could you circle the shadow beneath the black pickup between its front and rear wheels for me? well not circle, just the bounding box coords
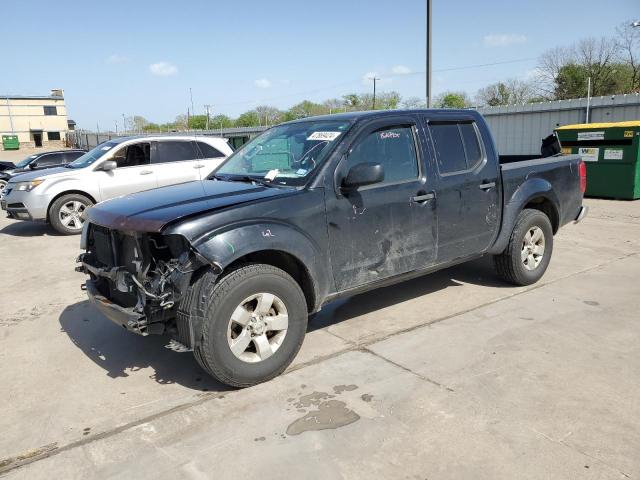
[307,257,513,332]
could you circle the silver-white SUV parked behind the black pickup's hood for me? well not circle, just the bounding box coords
[0,135,232,235]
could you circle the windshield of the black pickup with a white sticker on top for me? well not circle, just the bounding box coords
[214,120,351,186]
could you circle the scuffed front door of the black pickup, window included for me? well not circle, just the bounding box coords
[326,117,437,291]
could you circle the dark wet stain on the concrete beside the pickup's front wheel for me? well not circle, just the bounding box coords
[287,385,360,435]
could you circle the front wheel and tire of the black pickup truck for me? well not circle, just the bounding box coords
[185,264,308,387]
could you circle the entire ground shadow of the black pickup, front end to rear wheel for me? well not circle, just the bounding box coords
[59,258,511,391]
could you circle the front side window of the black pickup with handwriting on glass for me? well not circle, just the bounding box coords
[347,125,420,184]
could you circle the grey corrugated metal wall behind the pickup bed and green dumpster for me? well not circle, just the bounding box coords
[478,94,640,155]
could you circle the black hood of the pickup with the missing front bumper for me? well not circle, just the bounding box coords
[87,180,291,232]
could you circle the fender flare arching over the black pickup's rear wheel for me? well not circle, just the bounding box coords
[488,178,560,255]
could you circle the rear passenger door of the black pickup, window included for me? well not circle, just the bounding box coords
[428,116,499,263]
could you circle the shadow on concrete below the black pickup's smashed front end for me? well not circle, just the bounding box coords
[59,301,231,392]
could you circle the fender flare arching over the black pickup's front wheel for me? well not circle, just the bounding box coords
[192,220,330,308]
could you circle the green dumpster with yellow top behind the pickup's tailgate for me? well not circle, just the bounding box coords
[556,120,640,200]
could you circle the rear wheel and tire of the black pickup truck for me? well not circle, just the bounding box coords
[493,209,553,286]
